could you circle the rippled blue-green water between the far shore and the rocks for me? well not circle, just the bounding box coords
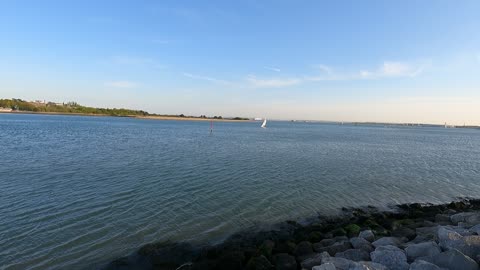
[0,114,480,269]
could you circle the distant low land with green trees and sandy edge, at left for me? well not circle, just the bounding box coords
[0,98,250,122]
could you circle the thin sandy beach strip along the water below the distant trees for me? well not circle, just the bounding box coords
[0,111,253,122]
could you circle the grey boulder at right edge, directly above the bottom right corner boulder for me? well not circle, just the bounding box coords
[438,227,480,258]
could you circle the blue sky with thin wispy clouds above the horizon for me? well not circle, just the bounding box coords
[0,0,480,125]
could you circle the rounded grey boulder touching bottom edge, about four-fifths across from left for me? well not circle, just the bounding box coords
[370,245,409,270]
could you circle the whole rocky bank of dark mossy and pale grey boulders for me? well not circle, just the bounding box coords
[105,199,480,270]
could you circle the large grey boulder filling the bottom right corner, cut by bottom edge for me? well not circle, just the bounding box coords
[422,249,480,270]
